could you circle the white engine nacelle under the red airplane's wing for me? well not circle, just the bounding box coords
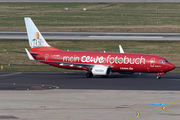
[92,65,111,76]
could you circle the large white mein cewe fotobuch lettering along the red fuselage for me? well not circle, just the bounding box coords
[53,55,145,65]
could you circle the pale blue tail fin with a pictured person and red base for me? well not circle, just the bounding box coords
[24,17,59,51]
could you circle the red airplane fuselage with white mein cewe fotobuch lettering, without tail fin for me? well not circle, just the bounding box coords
[31,51,175,73]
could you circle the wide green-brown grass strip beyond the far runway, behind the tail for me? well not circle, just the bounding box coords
[0,3,180,33]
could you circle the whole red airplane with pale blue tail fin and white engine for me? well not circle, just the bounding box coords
[24,17,175,79]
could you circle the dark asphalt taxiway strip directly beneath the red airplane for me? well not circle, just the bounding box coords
[0,71,180,91]
